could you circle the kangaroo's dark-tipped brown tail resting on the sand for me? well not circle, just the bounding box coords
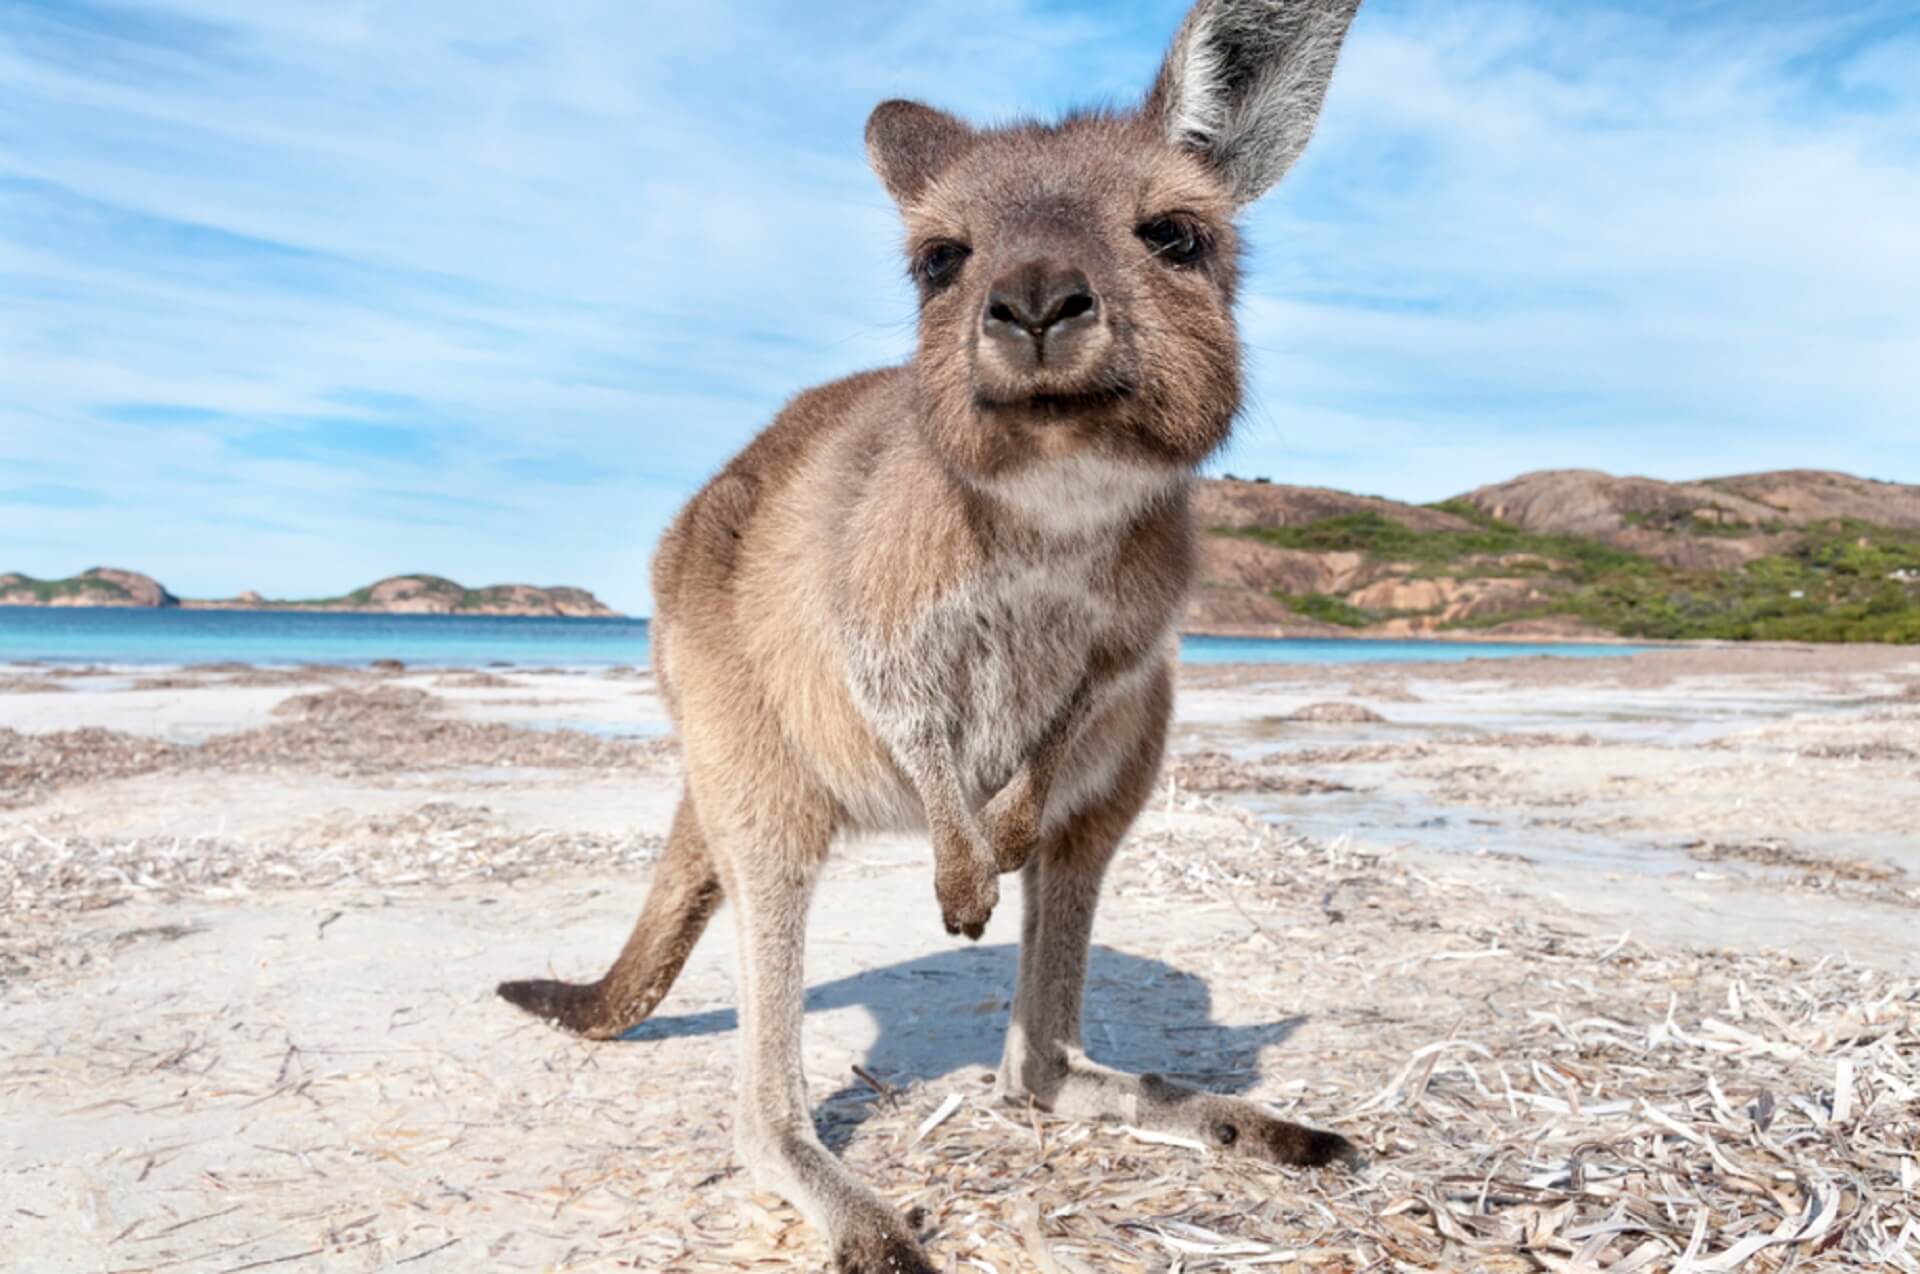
[499,796,722,1040]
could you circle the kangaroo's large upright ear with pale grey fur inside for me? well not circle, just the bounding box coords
[1146,0,1359,203]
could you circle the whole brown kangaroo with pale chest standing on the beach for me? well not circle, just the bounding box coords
[499,0,1359,1274]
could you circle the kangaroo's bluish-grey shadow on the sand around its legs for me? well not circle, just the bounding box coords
[620,944,1306,1149]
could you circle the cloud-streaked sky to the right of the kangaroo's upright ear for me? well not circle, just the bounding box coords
[1235,4,1920,497]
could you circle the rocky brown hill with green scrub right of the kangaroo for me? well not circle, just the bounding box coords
[1187,470,1920,641]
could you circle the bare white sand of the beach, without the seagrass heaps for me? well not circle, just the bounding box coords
[0,654,1920,1270]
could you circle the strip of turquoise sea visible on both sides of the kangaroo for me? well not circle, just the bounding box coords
[0,606,1642,668]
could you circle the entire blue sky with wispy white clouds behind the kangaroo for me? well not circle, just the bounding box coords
[0,0,1920,614]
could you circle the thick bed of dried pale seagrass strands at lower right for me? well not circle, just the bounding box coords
[814,796,1920,1274]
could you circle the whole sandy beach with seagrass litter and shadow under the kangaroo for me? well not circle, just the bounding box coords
[0,647,1920,1274]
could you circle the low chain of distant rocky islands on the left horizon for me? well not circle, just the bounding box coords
[0,566,620,620]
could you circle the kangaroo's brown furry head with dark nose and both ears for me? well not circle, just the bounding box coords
[866,0,1359,506]
